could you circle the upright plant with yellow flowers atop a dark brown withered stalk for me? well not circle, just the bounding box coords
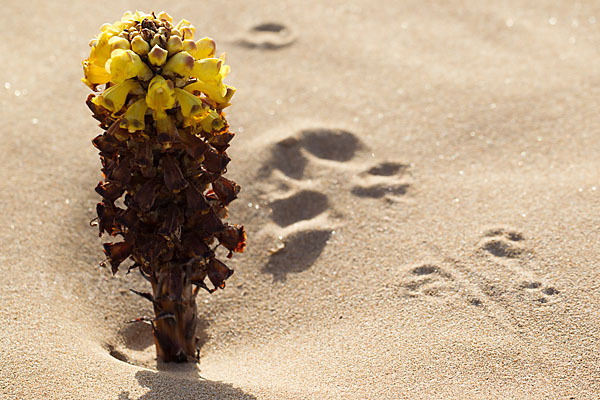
[82,11,246,362]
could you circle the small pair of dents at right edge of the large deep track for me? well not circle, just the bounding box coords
[352,161,410,201]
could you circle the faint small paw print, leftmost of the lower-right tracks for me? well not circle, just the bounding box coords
[401,264,454,297]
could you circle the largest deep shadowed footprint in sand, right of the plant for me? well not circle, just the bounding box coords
[257,128,410,280]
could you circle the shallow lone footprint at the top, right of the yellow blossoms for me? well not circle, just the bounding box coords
[236,22,296,50]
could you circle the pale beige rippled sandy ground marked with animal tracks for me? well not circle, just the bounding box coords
[0,0,600,399]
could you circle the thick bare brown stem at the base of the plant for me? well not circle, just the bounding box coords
[151,265,198,362]
